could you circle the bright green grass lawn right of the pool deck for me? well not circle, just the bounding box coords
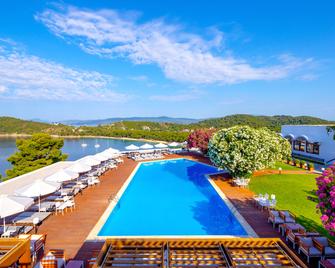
[249,174,335,240]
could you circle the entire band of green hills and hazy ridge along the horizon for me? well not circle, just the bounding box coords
[0,114,335,141]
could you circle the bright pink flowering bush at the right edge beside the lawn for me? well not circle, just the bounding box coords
[316,164,335,235]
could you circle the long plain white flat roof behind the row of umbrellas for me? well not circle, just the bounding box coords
[0,161,73,195]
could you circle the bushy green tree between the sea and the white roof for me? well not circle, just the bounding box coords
[6,133,67,178]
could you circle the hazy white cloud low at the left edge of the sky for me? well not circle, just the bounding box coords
[0,42,127,101]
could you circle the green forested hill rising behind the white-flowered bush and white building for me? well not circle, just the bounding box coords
[192,114,335,131]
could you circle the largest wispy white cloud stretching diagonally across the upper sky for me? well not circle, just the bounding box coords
[36,6,311,84]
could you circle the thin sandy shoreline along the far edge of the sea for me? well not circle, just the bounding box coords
[0,133,169,144]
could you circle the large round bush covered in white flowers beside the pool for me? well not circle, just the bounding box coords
[208,126,291,178]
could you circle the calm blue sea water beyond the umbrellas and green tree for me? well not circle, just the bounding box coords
[0,138,155,175]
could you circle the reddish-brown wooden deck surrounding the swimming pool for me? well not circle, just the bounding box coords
[38,155,279,260]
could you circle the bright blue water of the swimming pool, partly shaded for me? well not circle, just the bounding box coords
[98,159,246,236]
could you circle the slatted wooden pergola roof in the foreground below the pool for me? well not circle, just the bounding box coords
[95,238,307,267]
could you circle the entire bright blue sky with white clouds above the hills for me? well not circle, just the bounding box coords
[0,0,335,120]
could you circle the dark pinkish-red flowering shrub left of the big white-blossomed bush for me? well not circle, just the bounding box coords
[187,129,215,154]
